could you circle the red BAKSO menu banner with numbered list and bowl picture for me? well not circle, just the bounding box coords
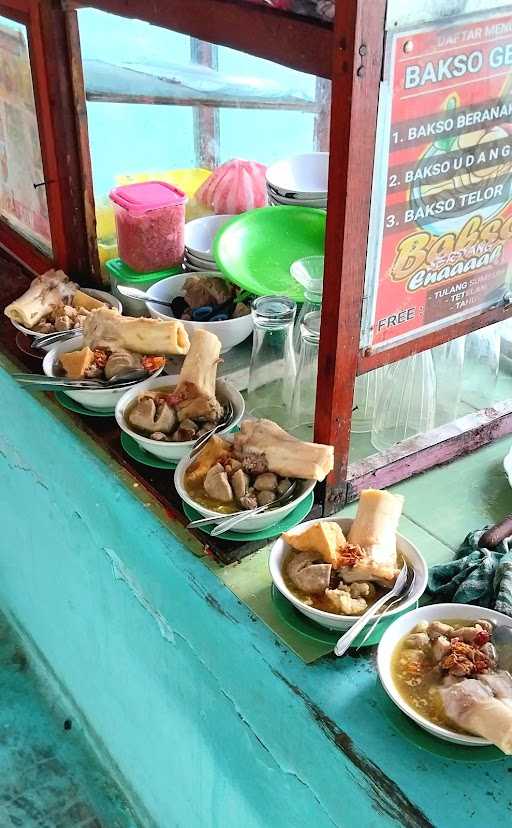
[366,14,512,347]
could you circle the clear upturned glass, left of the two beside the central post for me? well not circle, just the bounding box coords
[247,296,297,429]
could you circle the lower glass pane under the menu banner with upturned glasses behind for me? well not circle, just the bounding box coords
[350,320,512,461]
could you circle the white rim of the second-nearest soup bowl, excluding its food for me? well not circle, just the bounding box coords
[269,518,428,630]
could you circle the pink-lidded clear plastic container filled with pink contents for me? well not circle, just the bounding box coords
[109,181,187,273]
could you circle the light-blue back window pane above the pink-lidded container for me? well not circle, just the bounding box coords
[78,9,330,274]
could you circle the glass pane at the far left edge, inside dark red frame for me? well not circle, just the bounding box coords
[0,16,51,254]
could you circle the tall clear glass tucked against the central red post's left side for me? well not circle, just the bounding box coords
[292,311,321,441]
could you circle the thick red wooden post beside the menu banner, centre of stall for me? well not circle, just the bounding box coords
[315,0,386,514]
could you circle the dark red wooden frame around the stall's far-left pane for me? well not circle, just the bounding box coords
[0,0,90,279]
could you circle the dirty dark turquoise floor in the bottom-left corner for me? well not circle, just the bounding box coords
[0,616,138,828]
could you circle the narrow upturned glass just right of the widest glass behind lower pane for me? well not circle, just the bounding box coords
[432,336,465,426]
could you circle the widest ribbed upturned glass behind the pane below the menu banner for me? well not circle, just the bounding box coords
[371,351,436,451]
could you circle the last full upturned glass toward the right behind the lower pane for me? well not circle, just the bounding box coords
[461,325,500,409]
